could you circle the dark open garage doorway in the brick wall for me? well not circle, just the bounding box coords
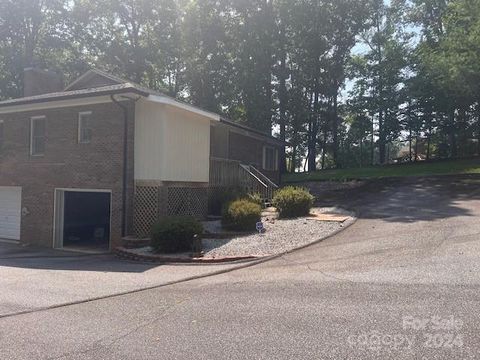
[63,191,110,250]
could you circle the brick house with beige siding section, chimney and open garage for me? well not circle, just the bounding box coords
[0,69,285,249]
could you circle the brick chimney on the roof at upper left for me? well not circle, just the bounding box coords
[23,67,64,97]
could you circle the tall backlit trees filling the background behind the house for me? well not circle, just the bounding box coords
[0,0,480,171]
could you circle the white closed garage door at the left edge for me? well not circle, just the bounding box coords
[0,186,22,240]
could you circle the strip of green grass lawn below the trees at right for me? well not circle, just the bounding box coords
[282,158,480,183]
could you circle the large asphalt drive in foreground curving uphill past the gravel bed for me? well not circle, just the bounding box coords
[0,177,480,359]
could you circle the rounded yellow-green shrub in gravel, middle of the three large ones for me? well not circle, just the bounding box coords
[222,199,262,231]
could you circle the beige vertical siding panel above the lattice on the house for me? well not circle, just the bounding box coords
[135,100,210,182]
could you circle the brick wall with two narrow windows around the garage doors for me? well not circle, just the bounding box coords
[0,103,134,247]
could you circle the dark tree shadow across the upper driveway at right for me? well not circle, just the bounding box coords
[319,175,480,223]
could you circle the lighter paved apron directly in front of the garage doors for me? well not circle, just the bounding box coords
[0,243,242,316]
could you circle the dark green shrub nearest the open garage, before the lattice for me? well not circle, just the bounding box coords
[151,217,203,254]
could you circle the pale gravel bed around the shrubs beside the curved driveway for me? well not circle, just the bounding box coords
[203,208,353,257]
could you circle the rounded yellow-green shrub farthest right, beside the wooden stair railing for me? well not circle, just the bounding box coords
[272,186,315,218]
